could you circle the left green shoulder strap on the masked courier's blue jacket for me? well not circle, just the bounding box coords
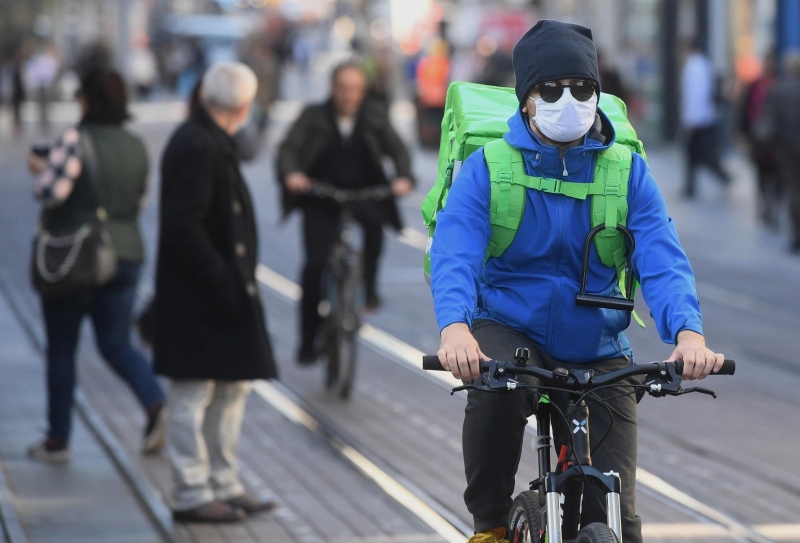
[483,138,525,260]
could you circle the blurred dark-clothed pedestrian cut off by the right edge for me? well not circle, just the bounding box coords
[764,51,800,254]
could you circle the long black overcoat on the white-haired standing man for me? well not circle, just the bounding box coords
[154,109,276,381]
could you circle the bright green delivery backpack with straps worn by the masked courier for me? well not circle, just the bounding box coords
[422,81,645,326]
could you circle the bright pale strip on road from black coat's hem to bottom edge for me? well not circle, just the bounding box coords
[254,381,471,543]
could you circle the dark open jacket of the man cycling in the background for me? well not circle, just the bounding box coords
[276,100,414,230]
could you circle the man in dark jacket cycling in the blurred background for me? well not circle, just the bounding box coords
[277,61,414,364]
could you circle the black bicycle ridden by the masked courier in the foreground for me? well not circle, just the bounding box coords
[422,349,736,543]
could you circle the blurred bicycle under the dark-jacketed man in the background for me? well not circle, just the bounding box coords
[309,182,391,399]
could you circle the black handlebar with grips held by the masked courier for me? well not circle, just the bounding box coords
[422,355,736,389]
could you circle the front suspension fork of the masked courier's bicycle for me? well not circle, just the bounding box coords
[536,401,622,543]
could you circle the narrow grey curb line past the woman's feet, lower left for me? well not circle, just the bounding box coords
[0,268,186,543]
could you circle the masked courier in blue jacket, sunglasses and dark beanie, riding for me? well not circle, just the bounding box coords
[431,21,723,543]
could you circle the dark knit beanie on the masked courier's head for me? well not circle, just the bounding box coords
[511,19,600,104]
